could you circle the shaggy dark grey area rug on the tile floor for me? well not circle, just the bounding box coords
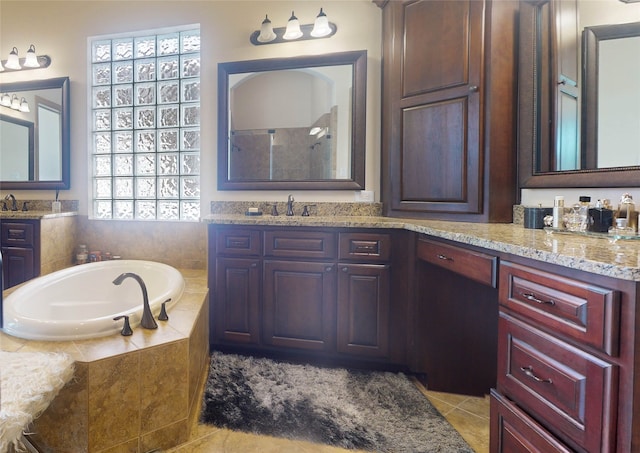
[200,351,473,453]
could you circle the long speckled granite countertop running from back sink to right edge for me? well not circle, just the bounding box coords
[203,214,640,281]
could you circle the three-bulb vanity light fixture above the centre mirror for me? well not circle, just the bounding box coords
[249,8,338,46]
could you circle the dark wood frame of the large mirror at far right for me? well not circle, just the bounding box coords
[518,0,640,189]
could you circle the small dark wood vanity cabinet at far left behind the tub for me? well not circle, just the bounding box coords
[0,219,40,288]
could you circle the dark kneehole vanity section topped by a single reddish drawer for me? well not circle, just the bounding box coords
[410,235,498,395]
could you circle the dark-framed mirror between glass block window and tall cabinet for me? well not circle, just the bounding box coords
[218,51,367,190]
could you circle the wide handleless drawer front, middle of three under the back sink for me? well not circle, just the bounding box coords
[264,229,337,259]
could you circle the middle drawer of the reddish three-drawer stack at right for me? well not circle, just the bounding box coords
[498,313,618,452]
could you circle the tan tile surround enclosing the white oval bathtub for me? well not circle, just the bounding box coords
[0,269,209,453]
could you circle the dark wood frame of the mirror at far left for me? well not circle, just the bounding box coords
[0,77,71,190]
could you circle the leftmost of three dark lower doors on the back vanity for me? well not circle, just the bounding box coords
[213,258,260,344]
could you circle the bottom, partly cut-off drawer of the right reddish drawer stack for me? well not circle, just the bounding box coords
[490,390,572,453]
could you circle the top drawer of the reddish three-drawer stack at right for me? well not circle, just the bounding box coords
[499,261,620,355]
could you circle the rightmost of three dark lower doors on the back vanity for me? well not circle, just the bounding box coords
[337,264,390,357]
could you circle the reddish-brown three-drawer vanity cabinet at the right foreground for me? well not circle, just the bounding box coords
[491,260,640,453]
